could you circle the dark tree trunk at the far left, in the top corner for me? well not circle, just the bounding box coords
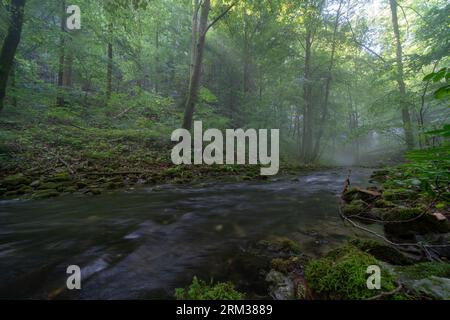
[0,0,25,111]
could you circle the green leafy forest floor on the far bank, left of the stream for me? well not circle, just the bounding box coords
[0,106,318,199]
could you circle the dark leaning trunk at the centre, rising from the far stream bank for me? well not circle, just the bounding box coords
[183,0,211,130]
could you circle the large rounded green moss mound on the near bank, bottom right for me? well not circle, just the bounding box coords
[305,245,396,300]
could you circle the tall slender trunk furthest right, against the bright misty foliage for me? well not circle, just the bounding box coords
[389,0,414,149]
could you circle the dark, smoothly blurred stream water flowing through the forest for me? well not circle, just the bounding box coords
[0,168,378,299]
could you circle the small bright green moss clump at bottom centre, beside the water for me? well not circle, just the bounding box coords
[175,277,245,300]
